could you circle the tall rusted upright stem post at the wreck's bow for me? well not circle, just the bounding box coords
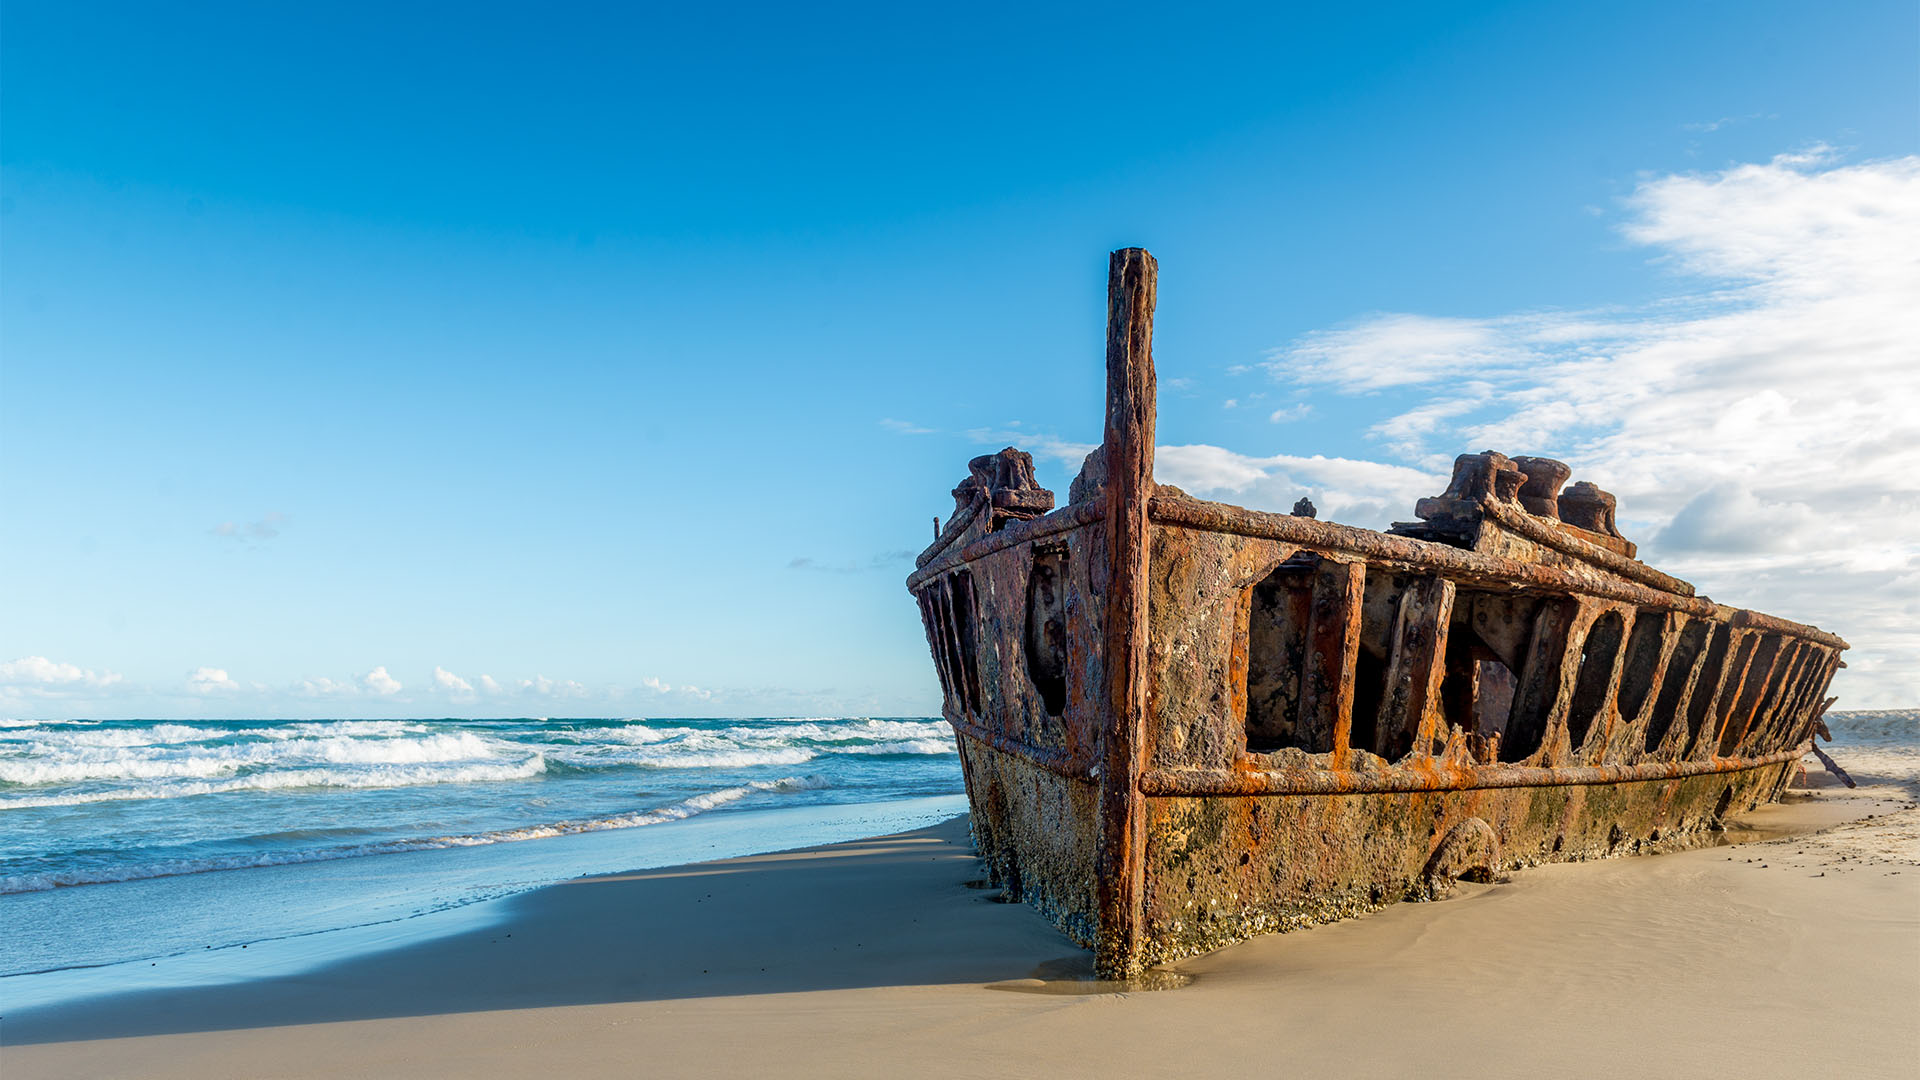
[1094,248,1160,978]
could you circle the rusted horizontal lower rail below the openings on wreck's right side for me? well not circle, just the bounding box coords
[1140,746,1807,798]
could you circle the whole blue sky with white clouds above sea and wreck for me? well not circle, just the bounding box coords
[0,2,1920,717]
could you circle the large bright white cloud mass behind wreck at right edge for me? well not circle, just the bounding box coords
[1244,146,1920,707]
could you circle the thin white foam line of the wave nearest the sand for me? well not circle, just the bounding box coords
[0,776,828,894]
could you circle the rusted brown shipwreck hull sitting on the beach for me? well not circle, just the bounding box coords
[906,248,1847,978]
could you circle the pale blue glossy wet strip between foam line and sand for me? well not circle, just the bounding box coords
[0,796,966,1011]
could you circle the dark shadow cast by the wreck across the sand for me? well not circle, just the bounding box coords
[0,821,1113,1045]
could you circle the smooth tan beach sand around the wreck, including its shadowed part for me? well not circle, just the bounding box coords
[0,776,1920,1080]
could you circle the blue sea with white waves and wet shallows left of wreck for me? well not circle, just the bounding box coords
[0,717,966,983]
